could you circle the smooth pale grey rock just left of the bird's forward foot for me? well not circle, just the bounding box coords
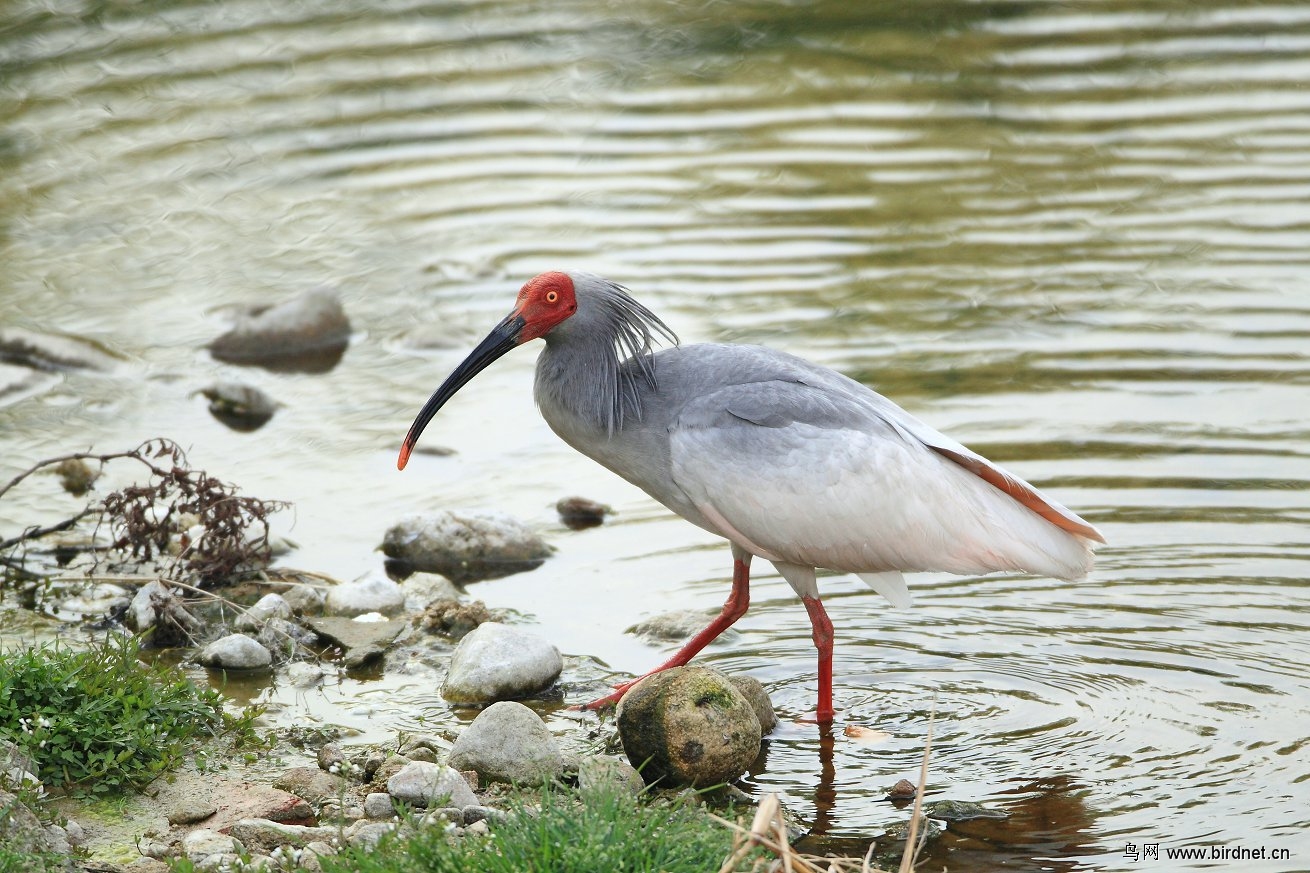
[441,621,563,704]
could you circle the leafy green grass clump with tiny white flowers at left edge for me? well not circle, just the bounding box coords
[0,637,227,796]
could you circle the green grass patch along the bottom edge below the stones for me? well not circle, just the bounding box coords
[322,788,753,873]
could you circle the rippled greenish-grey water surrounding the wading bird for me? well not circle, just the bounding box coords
[0,0,1310,870]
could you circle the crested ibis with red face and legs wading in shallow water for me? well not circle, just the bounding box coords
[397,271,1104,724]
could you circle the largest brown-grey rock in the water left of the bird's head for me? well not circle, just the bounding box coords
[210,287,350,372]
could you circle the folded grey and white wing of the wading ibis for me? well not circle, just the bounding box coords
[669,379,1086,587]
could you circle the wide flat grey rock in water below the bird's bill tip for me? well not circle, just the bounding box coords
[383,511,552,585]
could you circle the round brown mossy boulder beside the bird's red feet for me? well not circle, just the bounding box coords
[616,667,761,788]
